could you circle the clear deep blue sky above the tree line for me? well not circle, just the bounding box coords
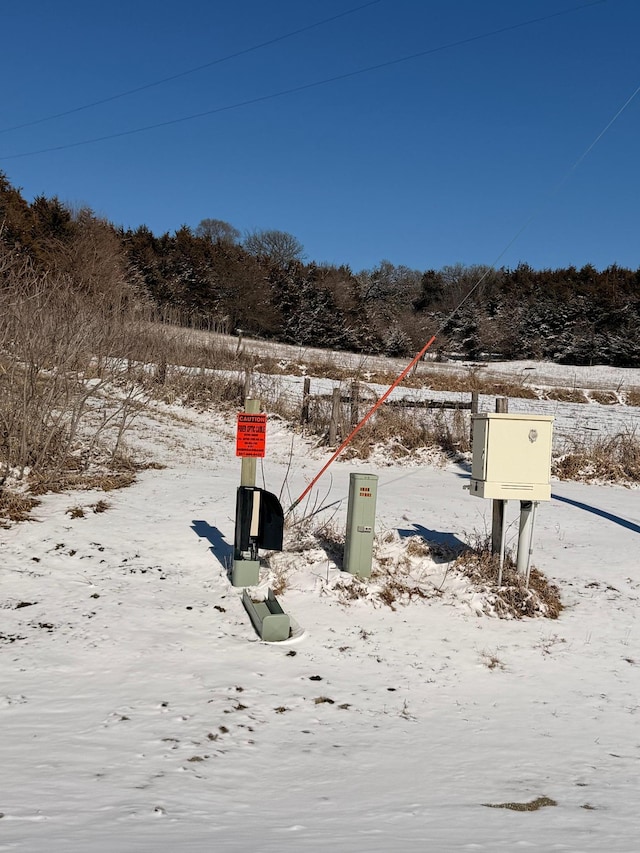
[0,0,640,271]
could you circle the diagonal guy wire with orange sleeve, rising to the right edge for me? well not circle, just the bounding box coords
[287,78,640,515]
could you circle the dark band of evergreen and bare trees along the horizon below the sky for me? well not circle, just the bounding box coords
[0,172,640,367]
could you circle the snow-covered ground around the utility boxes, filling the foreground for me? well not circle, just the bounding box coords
[0,365,640,853]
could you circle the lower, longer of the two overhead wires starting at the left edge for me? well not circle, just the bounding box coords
[0,0,607,160]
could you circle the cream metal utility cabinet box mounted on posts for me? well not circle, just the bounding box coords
[469,412,553,501]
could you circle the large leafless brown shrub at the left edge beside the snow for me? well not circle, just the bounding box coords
[0,241,150,520]
